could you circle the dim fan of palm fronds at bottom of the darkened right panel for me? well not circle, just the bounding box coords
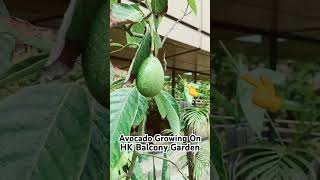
[233,144,318,180]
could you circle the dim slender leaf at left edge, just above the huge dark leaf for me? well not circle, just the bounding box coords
[0,54,49,87]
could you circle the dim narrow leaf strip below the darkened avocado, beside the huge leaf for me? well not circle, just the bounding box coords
[81,97,109,180]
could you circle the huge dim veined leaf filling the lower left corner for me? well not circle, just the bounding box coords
[0,84,91,180]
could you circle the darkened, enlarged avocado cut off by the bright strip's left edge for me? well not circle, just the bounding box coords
[82,1,110,107]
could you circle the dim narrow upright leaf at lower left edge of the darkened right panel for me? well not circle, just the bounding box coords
[210,129,227,180]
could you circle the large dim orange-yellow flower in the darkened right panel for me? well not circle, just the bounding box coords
[241,74,282,112]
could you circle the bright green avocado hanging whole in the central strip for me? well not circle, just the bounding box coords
[136,54,164,97]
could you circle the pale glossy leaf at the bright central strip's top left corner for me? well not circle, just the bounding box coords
[111,3,144,22]
